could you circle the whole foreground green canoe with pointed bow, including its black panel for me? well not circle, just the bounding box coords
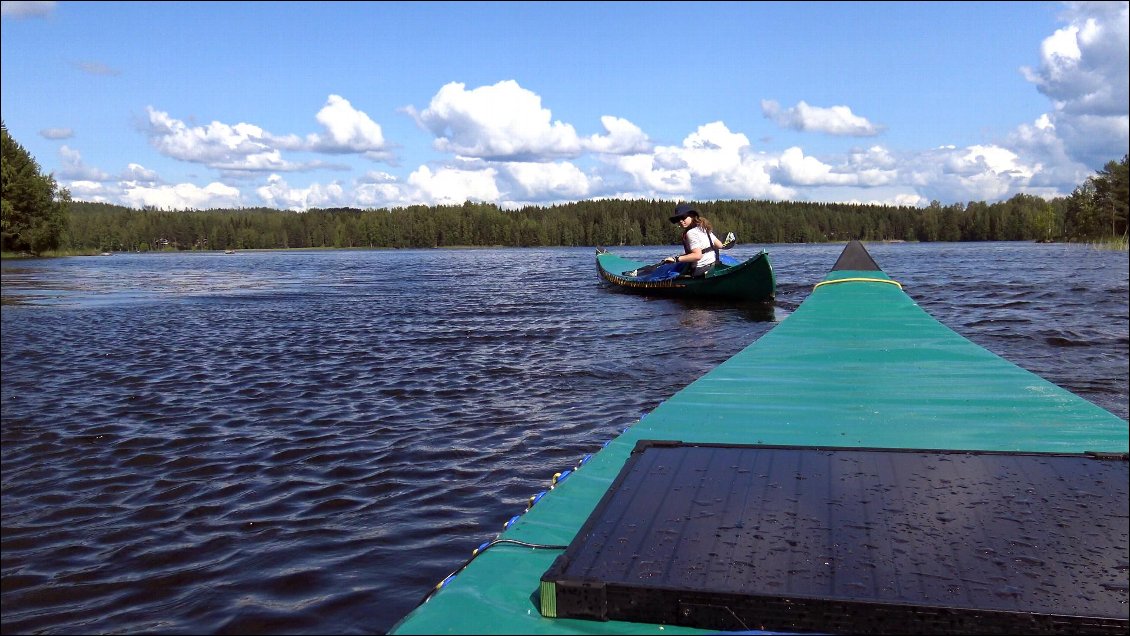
[392,242,1130,634]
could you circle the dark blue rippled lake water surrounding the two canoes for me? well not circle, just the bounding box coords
[0,243,1130,634]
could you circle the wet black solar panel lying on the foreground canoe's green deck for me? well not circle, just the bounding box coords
[540,441,1130,634]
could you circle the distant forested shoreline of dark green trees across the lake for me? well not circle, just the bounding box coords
[68,173,1127,252]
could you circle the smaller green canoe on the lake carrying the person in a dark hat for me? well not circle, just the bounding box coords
[597,251,776,302]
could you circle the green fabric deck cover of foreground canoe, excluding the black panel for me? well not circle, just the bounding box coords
[392,244,1130,634]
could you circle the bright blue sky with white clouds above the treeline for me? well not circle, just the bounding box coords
[0,1,1130,210]
